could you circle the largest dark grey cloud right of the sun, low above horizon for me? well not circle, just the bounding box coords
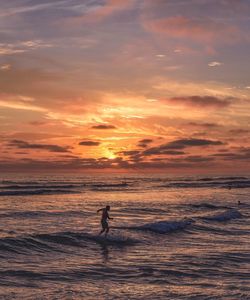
[142,139,223,155]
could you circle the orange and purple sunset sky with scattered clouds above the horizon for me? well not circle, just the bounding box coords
[0,0,250,174]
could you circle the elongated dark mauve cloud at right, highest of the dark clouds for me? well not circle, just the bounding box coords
[164,96,232,109]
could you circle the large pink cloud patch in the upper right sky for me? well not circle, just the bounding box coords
[143,16,241,43]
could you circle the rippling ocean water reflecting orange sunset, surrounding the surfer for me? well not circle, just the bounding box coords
[0,174,250,300]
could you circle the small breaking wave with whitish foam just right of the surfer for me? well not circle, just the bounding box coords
[116,219,194,234]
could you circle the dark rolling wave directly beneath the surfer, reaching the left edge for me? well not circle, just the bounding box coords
[0,232,139,254]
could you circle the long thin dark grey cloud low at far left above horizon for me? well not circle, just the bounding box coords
[8,140,70,152]
